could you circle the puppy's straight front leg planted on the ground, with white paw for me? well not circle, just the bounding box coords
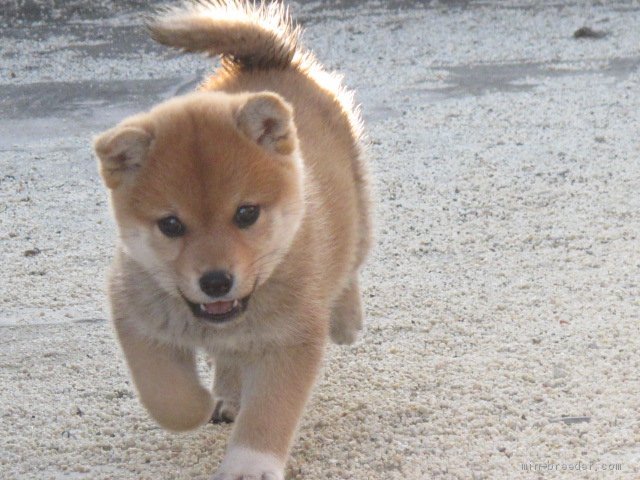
[214,341,324,480]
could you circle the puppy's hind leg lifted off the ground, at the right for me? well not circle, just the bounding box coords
[331,276,363,345]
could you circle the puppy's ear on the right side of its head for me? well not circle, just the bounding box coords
[235,92,297,155]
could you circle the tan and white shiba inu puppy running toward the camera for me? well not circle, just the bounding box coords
[94,0,371,480]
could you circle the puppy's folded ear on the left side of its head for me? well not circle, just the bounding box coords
[93,125,153,189]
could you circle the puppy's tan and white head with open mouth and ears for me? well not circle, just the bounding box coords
[94,93,304,323]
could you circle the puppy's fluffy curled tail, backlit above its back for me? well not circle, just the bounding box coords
[148,0,300,69]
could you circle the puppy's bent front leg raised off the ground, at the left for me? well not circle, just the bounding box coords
[114,318,213,431]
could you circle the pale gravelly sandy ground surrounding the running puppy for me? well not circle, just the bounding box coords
[0,0,640,480]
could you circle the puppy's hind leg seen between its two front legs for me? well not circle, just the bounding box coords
[211,355,242,423]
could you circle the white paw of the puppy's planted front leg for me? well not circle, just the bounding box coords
[213,447,284,480]
